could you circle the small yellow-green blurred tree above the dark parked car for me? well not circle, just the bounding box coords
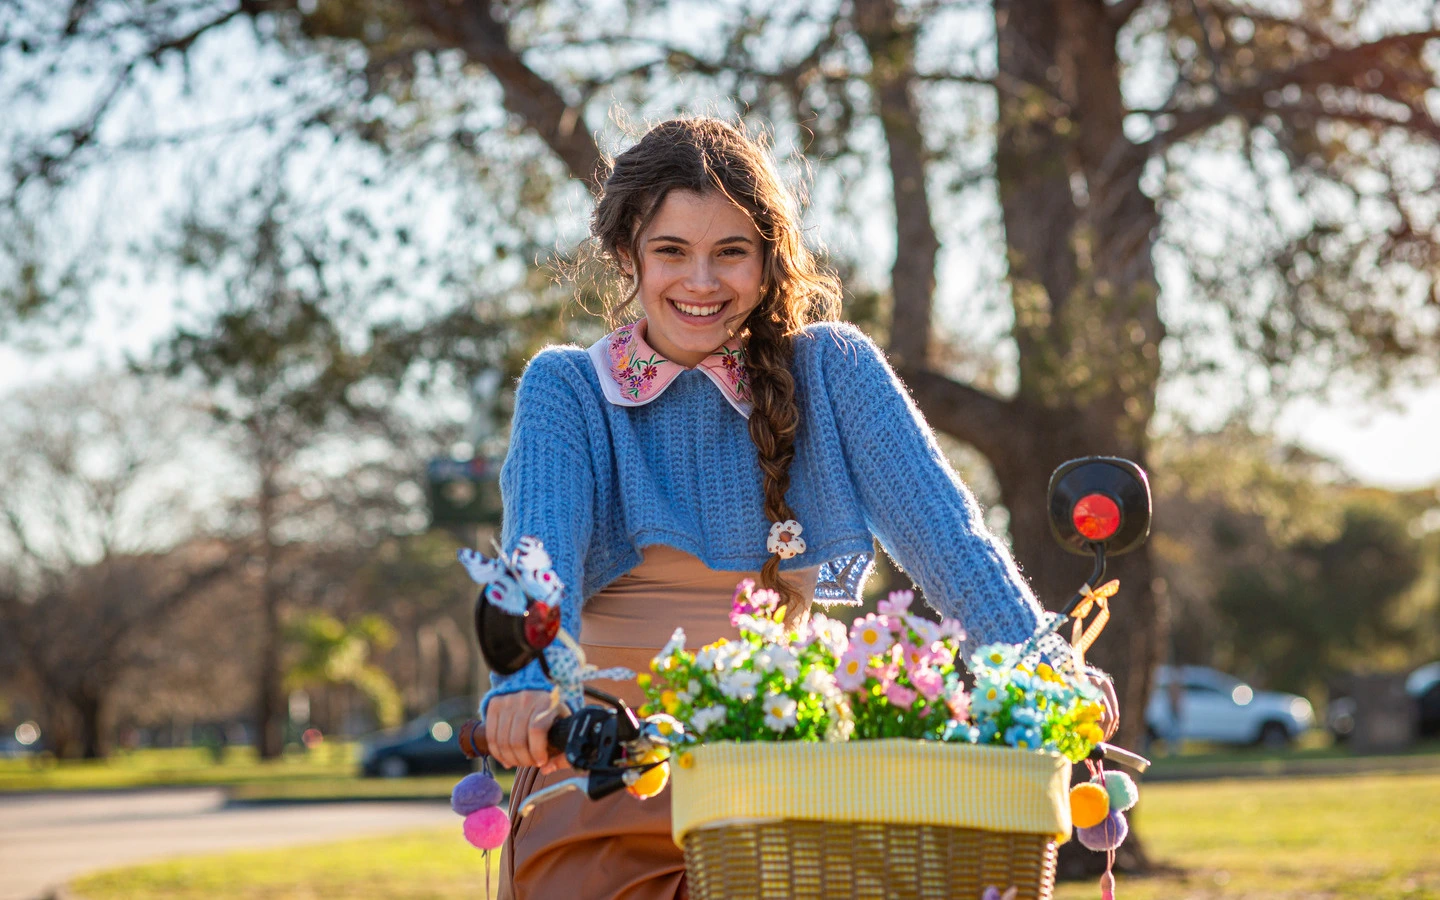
[285,612,403,729]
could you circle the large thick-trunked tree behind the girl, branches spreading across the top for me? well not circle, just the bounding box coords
[0,0,1440,848]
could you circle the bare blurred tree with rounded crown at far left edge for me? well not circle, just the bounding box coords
[0,374,243,759]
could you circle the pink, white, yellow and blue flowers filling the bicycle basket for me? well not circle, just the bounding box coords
[639,579,1102,762]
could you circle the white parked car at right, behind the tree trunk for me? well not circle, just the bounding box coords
[1145,665,1315,747]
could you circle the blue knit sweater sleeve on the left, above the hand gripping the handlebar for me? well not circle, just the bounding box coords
[480,350,595,716]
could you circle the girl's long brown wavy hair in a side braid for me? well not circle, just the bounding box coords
[590,117,840,622]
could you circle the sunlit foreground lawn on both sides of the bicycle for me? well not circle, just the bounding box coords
[75,773,1440,900]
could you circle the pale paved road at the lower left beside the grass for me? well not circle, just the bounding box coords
[0,788,456,900]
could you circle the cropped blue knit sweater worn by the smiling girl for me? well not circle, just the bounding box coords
[482,323,1065,708]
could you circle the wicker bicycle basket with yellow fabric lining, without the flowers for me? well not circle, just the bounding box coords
[671,739,1070,900]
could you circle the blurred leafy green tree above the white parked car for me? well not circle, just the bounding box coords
[1152,428,1440,698]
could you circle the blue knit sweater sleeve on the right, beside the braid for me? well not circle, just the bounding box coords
[818,327,1048,655]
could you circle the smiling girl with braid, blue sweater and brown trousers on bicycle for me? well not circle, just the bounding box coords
[482,118,1113,900]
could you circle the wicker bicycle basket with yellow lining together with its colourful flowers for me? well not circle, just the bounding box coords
[638,580,1135,897]
